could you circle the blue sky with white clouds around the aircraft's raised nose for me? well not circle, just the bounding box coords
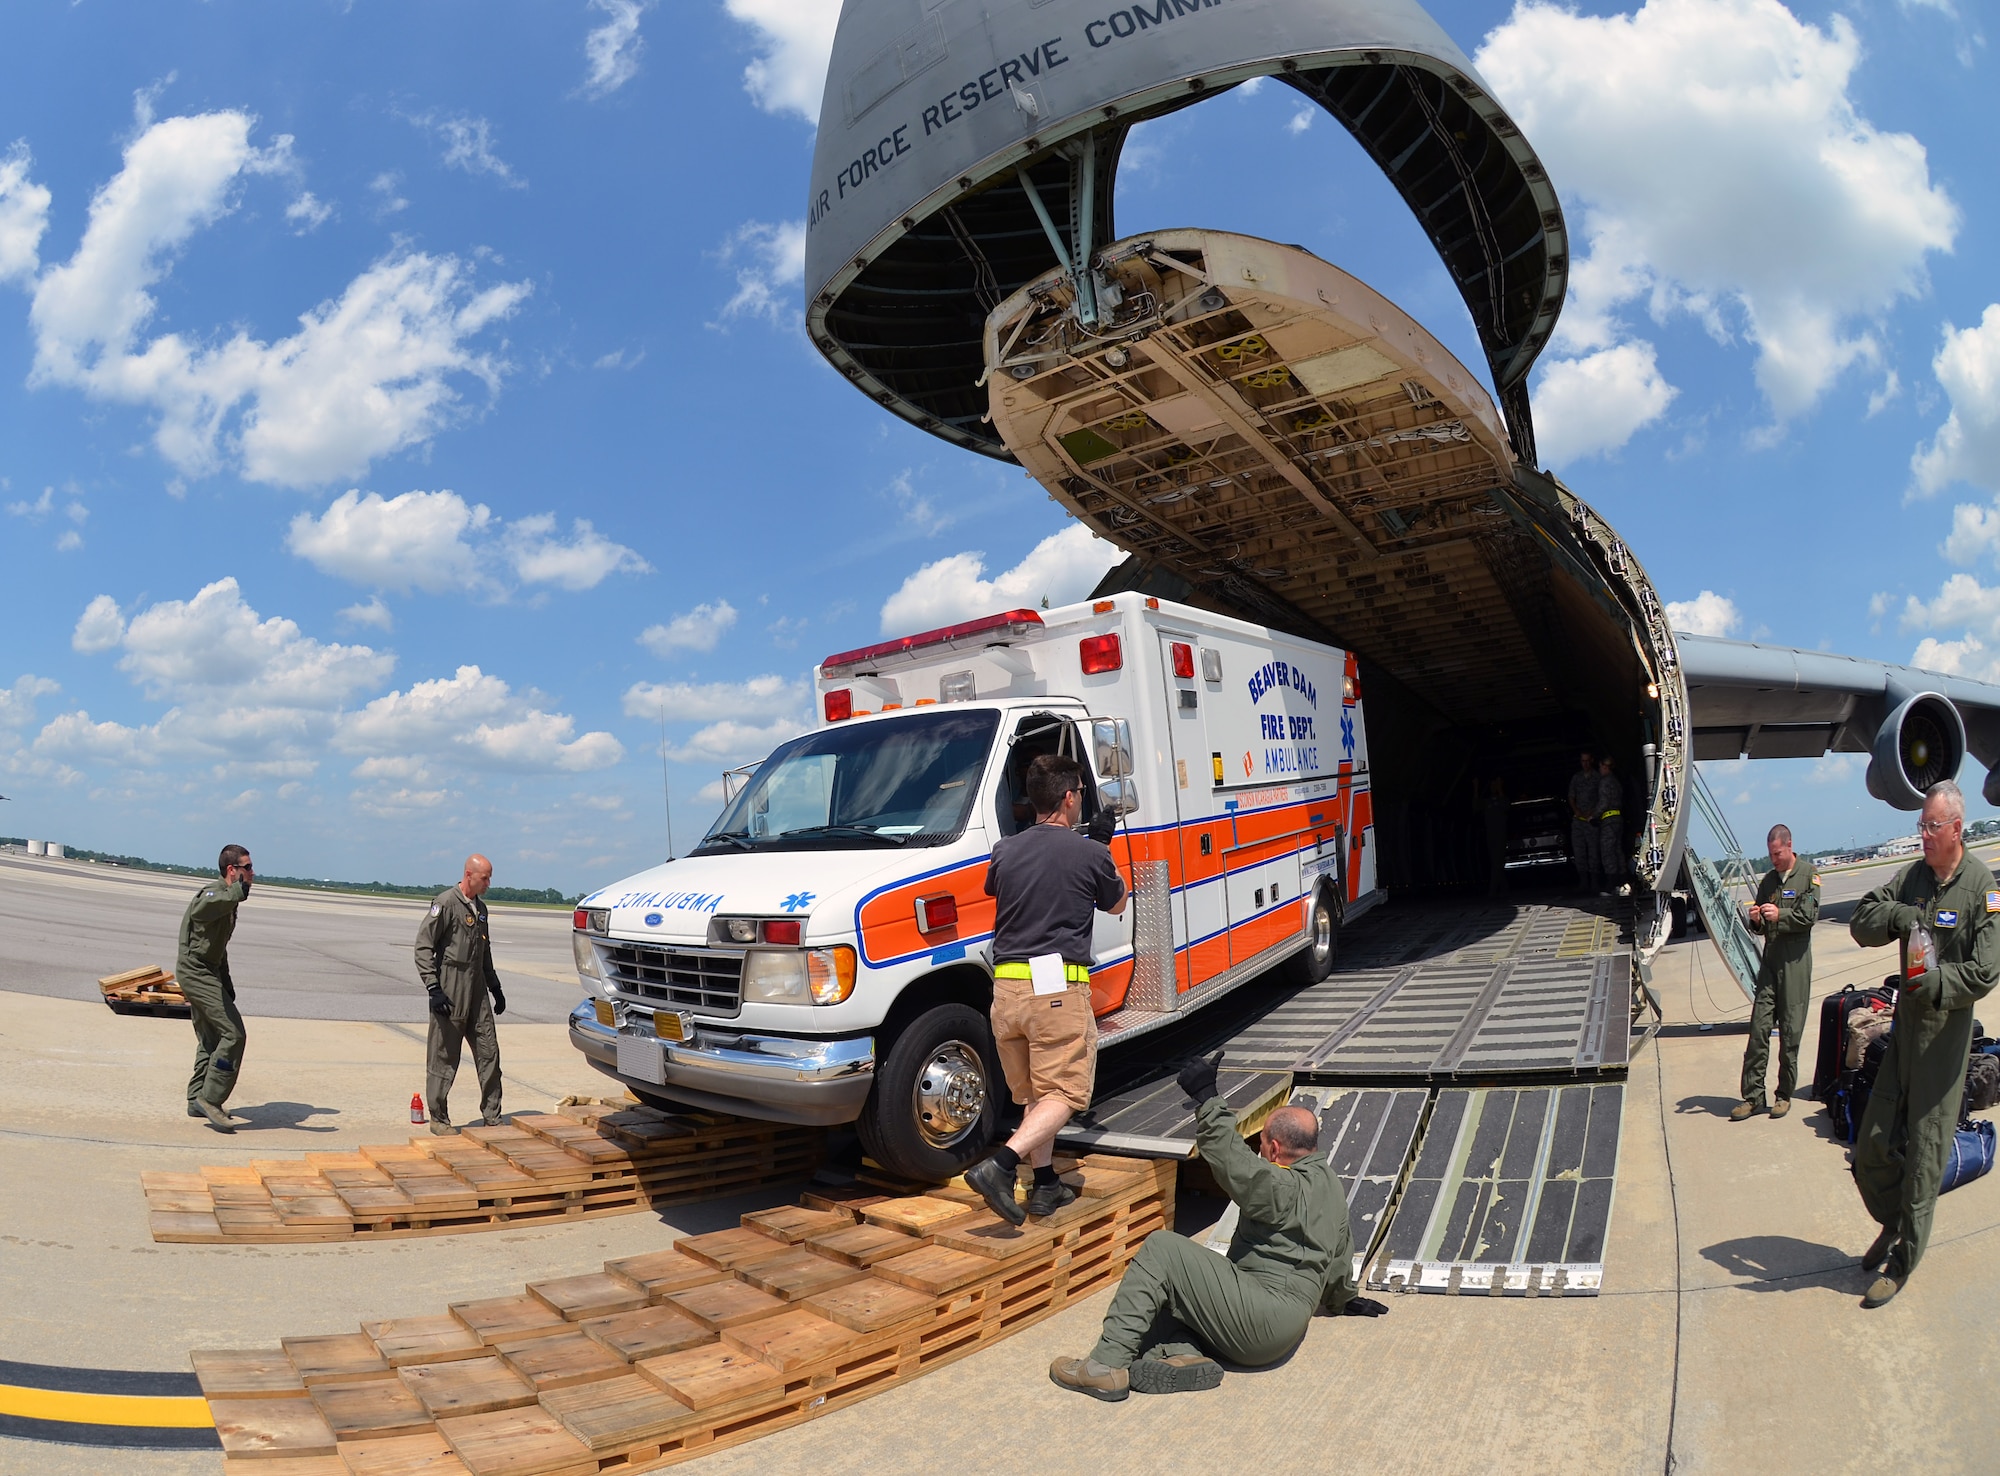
[0,0,2000,890]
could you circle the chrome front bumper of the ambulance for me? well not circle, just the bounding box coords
[570,1000,874,1126]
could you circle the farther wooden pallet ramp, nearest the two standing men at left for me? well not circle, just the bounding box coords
[140,1106,826,1246]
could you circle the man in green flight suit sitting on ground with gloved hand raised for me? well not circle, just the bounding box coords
[1048,1050,1388,1400]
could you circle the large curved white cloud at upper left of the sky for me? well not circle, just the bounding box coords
[5,112,530,486]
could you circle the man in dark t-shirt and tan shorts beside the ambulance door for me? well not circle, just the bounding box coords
[966,754,1126,1224]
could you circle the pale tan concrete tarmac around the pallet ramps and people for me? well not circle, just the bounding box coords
[0,872,2000,1476]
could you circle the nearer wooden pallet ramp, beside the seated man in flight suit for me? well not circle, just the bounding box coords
[192,1156,1174,1476]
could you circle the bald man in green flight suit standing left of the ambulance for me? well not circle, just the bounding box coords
[416,856,506,1134]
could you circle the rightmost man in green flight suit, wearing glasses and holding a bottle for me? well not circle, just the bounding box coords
[1848,780,2000,1306]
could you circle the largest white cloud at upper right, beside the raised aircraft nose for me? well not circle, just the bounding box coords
[1474,0,1958,422]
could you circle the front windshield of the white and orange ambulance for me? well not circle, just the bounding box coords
[694,710,1000,856]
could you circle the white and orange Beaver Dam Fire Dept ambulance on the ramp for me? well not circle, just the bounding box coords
[570,594,1382,1178]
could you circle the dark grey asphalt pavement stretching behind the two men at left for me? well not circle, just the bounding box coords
[0,854,580,1024]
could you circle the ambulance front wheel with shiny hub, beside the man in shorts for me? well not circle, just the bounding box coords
[854,1004,1006,1182]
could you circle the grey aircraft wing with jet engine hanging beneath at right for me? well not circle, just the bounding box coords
[1674,632,2000,810]
